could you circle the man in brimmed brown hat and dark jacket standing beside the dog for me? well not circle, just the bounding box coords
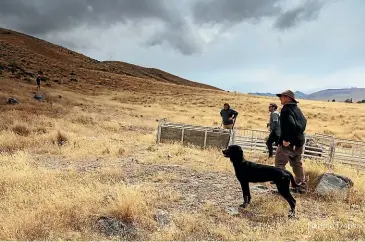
[275,90,307,193]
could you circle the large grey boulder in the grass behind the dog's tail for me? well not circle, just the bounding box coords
[315,173,354,200]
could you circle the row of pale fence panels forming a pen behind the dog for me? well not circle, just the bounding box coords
[157,120,365,168]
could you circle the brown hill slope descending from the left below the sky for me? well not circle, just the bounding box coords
[0,28,219,90]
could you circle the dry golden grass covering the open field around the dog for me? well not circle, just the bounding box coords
[0,80,365,240]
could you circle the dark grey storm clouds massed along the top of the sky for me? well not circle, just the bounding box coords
[0,0,328,55]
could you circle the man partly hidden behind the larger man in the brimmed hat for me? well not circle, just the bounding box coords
[266,103,280,158]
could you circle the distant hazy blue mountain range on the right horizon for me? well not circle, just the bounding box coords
[248,87,365,102]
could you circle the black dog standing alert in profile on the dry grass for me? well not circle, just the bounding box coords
[222,145,298,217]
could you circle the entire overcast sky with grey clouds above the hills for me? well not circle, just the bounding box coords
[0,0,365,93]
